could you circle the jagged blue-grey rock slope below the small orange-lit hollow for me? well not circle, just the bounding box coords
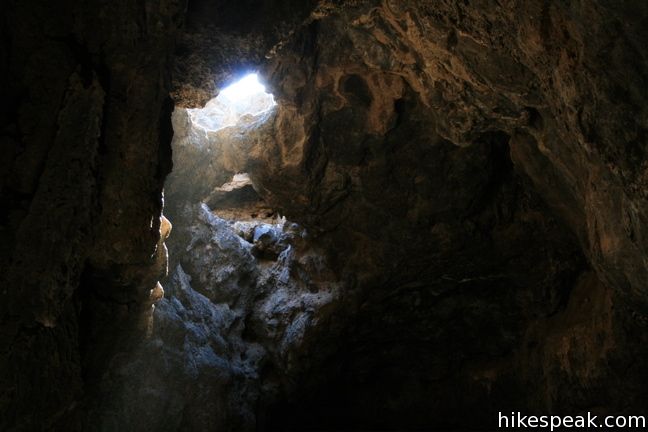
[111,205,340,431]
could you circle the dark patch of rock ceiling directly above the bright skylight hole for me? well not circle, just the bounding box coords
[171,0,318,108]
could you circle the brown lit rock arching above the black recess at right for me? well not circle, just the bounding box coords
[254,2,646,304]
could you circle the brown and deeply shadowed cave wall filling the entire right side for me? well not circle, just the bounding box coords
[168,1,648,430]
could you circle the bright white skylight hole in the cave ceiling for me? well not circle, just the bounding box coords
[187,73,276,131]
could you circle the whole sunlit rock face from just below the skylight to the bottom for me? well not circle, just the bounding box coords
[159,89,346,431]
